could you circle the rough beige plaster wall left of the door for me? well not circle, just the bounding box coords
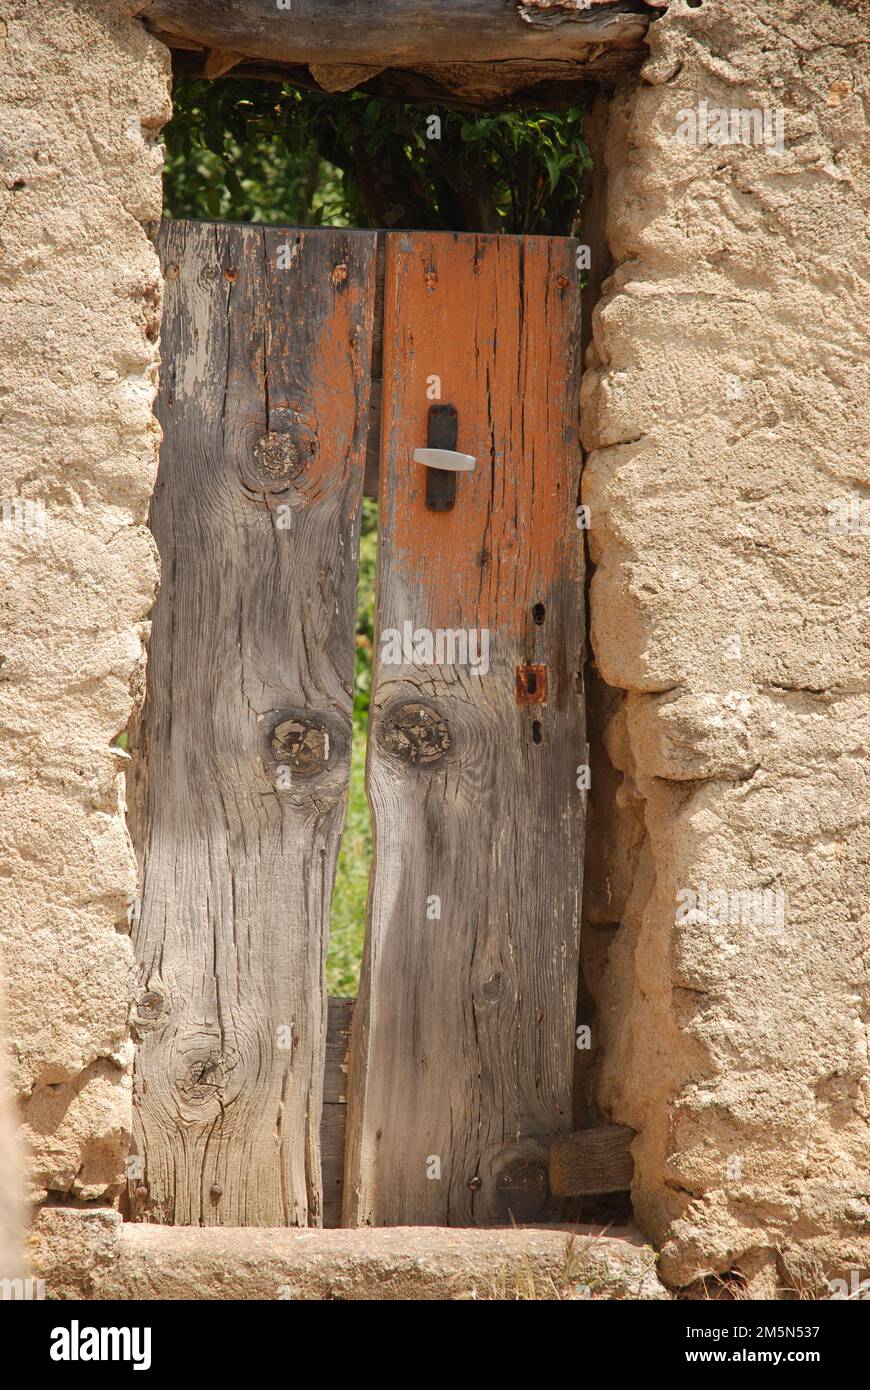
[0,0,168,1200]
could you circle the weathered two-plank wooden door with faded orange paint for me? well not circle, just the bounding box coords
[131,216,586,1225]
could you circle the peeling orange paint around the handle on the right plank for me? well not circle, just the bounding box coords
[381,232,581,631]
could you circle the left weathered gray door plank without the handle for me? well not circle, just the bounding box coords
[131,222,375,1226]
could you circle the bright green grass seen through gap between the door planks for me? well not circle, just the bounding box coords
[327,498,378,994]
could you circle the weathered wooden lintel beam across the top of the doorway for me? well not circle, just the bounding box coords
[136,0,660,68]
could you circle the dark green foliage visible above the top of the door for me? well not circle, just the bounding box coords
[164,78,591,235]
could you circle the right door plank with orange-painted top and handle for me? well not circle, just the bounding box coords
[345,232,585,1225]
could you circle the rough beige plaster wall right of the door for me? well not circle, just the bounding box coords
[575,0,870,1295]
